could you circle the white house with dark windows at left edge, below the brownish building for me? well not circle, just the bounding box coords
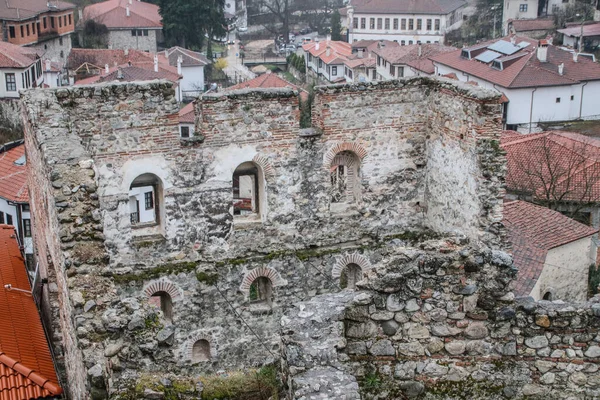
[0,42,44,98]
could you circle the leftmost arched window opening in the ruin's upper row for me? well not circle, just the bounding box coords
[129,174,162,226]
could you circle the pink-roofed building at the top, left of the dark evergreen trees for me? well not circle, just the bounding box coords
[78,0,163,52]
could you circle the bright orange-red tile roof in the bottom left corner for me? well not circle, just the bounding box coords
[0,225,62,400]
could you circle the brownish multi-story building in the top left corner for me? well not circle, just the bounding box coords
[0,0,75,61]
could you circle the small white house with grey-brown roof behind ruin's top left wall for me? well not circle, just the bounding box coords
[164,46,209,98]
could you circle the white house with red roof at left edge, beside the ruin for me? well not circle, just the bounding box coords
[0,140,35,269]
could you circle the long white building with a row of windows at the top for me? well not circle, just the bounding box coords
[340,0,467,44]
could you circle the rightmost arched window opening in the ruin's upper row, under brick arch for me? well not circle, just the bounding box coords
[329,151,360,203]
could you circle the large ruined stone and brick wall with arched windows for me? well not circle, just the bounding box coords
[23,78,504,398]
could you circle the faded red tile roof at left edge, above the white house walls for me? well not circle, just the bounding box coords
[0,142,29,205]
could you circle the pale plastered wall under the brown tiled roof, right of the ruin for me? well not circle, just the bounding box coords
[530,236,593,302]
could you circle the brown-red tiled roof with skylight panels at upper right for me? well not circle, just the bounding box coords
[431,35,600,88]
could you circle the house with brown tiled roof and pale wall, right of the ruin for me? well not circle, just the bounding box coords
[503,200,598,302]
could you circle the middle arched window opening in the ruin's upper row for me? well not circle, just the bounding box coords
[233,162,265,218]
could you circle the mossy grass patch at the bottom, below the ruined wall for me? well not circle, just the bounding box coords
[199,366,281,400]
